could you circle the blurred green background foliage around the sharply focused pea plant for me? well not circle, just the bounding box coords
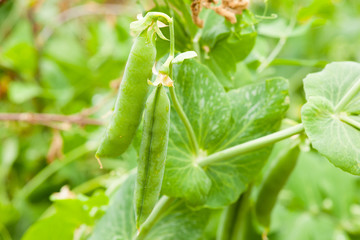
[0,0,360,240]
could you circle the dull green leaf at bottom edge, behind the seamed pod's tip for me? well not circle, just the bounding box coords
[90,175,210,240]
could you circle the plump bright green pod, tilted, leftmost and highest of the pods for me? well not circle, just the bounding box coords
[96,30,156,159]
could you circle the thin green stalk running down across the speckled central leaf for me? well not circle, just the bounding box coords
[169,87,199,156]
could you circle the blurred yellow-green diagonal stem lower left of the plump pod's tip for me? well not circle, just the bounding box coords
[17,145,89,201]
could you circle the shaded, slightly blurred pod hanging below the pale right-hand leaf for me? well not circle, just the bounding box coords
[255,142,300,230]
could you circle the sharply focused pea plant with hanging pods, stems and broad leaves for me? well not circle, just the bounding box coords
[91,7,360,239]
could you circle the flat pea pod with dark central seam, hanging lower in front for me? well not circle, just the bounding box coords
[135,85,170,229]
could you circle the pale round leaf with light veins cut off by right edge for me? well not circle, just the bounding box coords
[301,62,360,175]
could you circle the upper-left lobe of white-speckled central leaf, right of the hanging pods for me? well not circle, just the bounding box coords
[172,60,231,154]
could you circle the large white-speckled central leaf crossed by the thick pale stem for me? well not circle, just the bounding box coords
[162,60,288,208]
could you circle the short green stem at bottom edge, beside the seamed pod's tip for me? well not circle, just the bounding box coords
[135,196,175,240]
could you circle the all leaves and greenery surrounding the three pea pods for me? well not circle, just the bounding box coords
[0,0,360,240]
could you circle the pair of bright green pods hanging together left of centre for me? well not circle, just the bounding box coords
[96,29,170,228]
